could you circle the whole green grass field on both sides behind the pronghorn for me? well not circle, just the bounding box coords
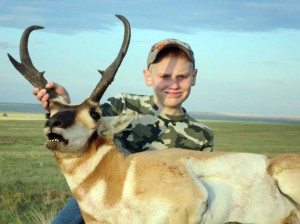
[0,114,300,224]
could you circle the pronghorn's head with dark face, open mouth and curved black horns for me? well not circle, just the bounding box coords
[8,15,130,155]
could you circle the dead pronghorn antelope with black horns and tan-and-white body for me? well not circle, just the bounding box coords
[9,16,300,224]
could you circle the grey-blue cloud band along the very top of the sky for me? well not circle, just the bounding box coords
[0,0,300,33]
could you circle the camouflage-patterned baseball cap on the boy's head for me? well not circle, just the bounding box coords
[147,39,195,68]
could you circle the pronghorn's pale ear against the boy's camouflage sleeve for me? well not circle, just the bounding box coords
[97,113,134,134]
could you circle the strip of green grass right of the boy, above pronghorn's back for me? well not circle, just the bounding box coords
[205,121,300,155]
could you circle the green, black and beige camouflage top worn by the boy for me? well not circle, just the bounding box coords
[101,93,213,154]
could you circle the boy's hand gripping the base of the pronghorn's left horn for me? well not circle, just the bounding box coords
[32,81,71,110]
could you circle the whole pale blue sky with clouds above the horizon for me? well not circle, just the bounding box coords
[0,0,300,116]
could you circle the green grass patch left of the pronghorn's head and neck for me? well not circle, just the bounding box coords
[0,120,70,224]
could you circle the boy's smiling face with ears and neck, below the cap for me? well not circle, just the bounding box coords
[144,56,197,115]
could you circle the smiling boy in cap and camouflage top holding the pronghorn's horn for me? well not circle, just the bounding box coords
[33,39,213,223]
